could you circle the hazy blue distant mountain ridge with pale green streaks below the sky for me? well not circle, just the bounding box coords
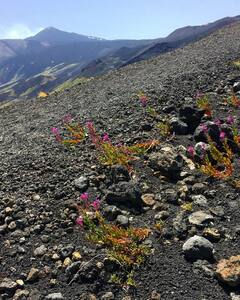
[0,16,240,101]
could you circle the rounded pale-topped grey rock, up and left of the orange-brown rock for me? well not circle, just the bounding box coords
[182,235,213,261]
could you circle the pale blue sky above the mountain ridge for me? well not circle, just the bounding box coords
[0,0,240,39]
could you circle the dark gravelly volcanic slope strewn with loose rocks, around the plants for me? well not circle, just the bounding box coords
[0,23,240,300]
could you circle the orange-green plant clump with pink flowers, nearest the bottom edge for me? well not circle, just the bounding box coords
[76,193,150,284]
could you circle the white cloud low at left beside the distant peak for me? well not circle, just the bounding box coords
[0,24,43,39]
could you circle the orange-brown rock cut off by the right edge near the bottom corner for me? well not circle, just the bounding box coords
[216,255,240,287]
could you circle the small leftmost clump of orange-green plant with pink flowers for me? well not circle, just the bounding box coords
[51,115,86,146]
